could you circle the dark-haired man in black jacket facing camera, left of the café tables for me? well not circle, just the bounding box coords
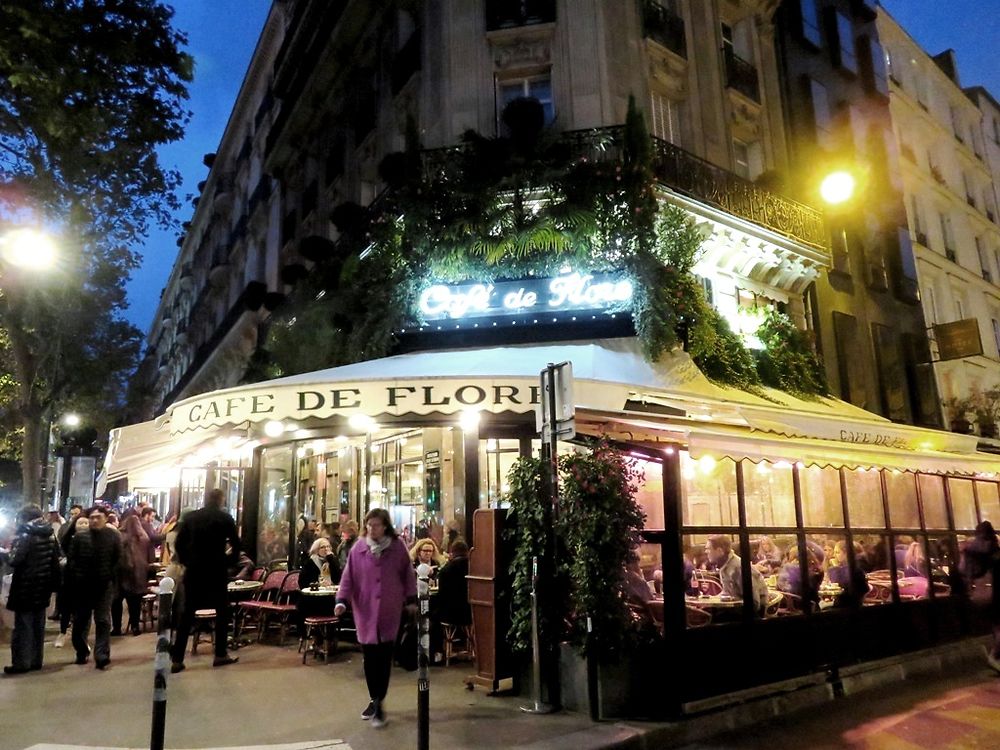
[66,505,122,670]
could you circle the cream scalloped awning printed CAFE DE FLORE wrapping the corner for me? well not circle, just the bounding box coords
[105,338,1000,494]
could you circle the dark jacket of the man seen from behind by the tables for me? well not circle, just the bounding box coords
[174,507,240,587]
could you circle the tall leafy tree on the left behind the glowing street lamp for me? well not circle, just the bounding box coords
[0,0,193,500]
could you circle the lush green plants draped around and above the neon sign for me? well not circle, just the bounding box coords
[254,98,825,400]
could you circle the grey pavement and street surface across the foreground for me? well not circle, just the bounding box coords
[0,631,1000,750]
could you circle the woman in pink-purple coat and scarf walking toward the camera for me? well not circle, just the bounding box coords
[334,508,417,727]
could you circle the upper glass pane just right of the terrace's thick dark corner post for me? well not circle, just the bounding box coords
[681,451,740,526]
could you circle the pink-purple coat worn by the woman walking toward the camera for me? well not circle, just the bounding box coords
[337,537,417,643]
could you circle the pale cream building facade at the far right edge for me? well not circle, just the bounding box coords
[876,11,1000,437]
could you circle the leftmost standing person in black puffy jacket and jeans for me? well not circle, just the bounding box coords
[3,505,60,674]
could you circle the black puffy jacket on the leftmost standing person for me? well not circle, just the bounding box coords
[7,518,60,612]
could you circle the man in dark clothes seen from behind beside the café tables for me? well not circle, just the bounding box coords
[170,489,240,674]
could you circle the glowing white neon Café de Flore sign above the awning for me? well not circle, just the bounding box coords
[418,273,632,321]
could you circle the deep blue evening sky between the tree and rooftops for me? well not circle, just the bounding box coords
[126,0,1000,332]
